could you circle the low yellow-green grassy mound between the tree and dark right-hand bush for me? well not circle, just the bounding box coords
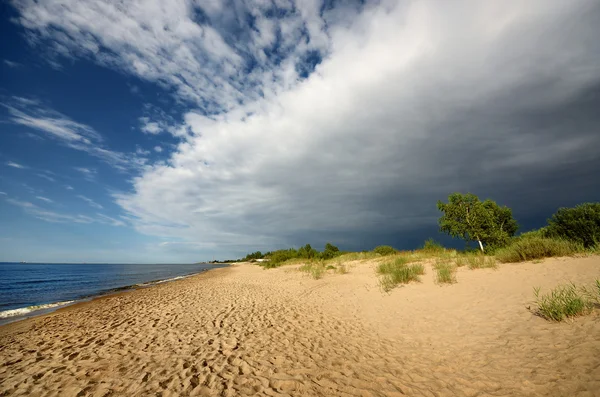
[496,237,583,263]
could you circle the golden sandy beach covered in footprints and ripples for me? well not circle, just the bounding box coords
[0,256,600,396]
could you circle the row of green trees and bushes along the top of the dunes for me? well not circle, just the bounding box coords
[210,200,600,267]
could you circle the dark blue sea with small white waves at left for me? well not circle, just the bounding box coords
[0,262,226,325]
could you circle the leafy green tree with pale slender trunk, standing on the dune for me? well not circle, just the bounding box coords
[437,193,518,252]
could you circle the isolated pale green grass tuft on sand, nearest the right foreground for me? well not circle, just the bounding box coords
[533,280,598,321]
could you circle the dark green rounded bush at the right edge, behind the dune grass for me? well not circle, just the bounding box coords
[546,203,600,248]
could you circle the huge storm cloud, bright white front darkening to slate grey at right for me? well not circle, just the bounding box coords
[11,0,600,254]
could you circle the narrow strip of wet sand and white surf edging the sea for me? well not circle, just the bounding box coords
[0,264,231,328]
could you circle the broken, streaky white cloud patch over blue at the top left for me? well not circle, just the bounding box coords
[13,0,336,113]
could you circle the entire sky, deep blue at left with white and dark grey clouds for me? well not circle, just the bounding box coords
[0,0,600,263]
